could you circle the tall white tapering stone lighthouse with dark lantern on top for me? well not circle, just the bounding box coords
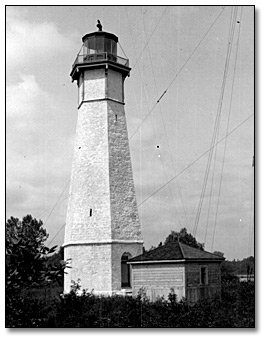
[64,27,143,294]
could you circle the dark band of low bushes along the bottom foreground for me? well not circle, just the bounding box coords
[7,282,255,328]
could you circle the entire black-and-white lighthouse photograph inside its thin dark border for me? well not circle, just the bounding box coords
[5,3,255,332]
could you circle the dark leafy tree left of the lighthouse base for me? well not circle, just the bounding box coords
[6,215,66,291]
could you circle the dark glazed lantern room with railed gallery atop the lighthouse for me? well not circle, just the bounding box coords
[70,31,130,81]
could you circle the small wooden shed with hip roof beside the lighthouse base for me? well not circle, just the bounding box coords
[127,242,224,303]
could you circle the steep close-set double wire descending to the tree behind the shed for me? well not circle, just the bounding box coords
[193,5,236,236]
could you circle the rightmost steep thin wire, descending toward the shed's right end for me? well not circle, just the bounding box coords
[211,7,243,251]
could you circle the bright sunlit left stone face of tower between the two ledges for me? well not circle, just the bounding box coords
[65,101,111,244]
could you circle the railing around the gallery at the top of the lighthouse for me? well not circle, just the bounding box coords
[72,52,129,68]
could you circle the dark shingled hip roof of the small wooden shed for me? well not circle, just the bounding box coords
[128,242,224,264]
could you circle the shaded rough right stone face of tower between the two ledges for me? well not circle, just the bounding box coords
[108,101,142,240]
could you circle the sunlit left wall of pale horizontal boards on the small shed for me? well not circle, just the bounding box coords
[132,263,185,301]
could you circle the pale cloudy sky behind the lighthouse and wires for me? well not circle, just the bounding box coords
[6,6,254,260]
